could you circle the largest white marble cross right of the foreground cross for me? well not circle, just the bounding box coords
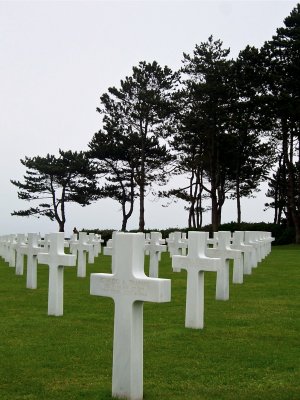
[172,231,223,329]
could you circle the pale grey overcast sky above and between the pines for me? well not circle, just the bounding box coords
[0,0,297,234]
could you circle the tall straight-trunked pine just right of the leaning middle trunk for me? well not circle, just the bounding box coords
[94,61,177,231]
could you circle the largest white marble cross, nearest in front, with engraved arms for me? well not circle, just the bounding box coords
[90,232,171,400]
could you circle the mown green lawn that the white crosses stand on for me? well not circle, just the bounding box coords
[0,245,300,400]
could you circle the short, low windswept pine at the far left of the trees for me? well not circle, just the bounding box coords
[11,150,99,232]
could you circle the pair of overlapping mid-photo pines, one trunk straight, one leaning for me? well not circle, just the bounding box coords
[89,61,178,230]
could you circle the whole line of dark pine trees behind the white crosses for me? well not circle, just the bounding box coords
[12,4,300,243]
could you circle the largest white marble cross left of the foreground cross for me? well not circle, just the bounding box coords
[38,233,76,316]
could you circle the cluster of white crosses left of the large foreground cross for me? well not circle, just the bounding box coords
[0,232,102,316]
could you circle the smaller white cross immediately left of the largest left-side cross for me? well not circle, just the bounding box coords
[23,233,44,289]
